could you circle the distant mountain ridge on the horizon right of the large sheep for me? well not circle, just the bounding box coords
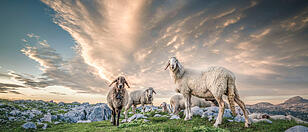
[247,96,308,121]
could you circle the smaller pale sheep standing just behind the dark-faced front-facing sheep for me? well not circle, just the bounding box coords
[124,87,156,119]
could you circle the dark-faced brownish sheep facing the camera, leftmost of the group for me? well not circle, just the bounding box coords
[107,76,130,126]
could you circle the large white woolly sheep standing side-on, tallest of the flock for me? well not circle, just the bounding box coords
[165,57,250,127]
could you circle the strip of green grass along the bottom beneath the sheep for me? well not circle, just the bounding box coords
[0,117,308,132]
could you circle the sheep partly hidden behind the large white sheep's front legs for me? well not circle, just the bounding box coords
[170,95,211,115]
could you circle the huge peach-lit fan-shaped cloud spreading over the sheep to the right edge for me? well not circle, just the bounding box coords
[38,0,308,102]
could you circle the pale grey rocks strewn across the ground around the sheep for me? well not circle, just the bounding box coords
[0,100,308,131]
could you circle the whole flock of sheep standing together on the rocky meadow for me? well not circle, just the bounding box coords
[107,57,250,127]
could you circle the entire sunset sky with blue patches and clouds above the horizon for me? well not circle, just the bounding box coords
[0,0,308,104]
